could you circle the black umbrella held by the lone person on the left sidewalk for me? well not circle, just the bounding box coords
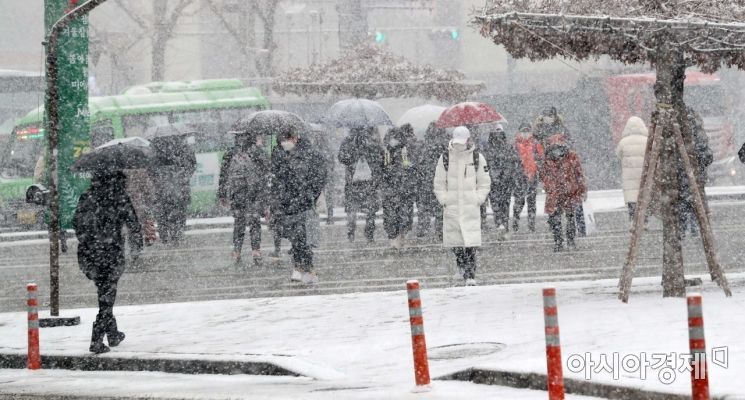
[70,137,153,174]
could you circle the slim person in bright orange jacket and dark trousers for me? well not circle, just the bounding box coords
[512,124,544,232]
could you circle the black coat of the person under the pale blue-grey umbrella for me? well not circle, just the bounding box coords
[339,130,384,211]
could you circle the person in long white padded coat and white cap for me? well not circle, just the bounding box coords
[434,126,491,286]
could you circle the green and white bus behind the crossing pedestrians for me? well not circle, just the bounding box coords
[0,79,269,227]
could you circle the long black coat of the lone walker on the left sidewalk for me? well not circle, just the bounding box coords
[73,174,142,282]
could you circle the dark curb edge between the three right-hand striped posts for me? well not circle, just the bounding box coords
[436,368,725,400]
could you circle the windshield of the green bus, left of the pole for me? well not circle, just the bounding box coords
[0,126,44,179]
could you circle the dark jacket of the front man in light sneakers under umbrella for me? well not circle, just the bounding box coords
[271,138,327,219]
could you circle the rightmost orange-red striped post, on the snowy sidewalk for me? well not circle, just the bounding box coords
[688,294,709,400]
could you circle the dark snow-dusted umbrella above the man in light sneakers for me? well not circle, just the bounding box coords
[231,110,310,138]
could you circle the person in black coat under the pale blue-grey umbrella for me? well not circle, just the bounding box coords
[338,128,383,242]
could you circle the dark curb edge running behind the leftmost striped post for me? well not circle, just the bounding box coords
[0,354,302,377]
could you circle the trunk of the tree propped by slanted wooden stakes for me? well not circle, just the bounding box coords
[654,45,685,297]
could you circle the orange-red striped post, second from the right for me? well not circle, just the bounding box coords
[543,288,564,400]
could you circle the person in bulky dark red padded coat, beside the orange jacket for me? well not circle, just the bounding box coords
[540,130,587,252]
